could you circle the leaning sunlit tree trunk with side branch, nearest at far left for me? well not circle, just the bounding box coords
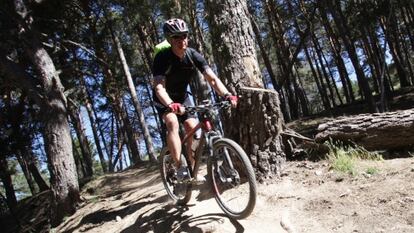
[0,0,79,226]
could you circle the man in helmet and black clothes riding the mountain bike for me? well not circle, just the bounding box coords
[153,18,237,179]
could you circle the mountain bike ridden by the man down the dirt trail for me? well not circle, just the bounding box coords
[160,101,257,219]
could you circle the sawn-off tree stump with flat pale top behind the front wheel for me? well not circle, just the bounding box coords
[225,87,286,177]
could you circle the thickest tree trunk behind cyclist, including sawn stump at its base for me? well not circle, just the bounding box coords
[206,0,285,175]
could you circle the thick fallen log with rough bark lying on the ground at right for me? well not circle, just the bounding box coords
[315,109,414,150]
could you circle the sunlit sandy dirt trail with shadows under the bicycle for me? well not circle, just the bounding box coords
[54,158,414,233]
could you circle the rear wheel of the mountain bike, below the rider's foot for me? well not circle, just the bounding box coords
[160,147,192,205]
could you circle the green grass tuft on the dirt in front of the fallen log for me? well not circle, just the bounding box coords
[326,140,382,176]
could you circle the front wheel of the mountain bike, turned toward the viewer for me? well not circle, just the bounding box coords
[207,138,257,219]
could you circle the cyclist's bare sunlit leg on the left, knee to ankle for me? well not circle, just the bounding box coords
[163,112,181,168]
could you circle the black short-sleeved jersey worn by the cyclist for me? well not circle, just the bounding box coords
[153,48,209,103]
